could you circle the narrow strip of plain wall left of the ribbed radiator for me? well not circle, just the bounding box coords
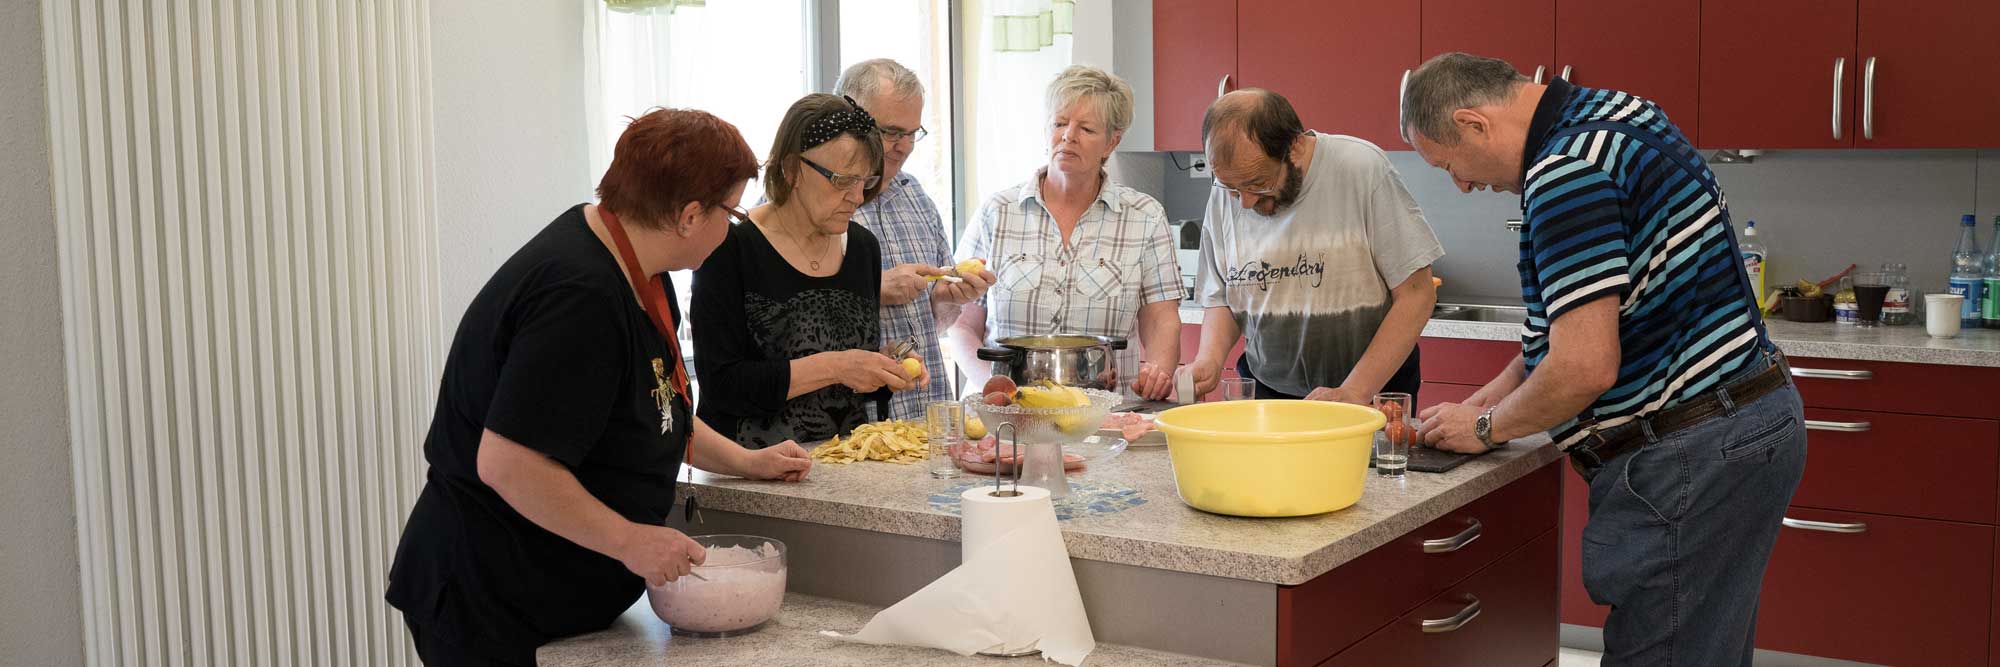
[0,2,84,665]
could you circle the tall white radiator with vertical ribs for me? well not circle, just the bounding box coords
[43,0,442,667]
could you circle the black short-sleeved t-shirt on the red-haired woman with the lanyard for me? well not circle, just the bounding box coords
[388,206,694,655]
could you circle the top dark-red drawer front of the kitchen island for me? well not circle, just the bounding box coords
[1278,461,1564,665]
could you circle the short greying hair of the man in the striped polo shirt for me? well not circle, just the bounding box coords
[1402,52,1530,146]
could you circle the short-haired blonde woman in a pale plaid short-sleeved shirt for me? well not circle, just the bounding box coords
[950,66,1184,399]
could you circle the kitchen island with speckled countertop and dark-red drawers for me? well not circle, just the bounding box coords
[540,429,1562,665]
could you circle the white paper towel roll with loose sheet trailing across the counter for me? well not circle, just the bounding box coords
[846,487,1098,665]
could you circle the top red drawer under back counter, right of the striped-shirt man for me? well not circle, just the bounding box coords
[1792,357,2000,419]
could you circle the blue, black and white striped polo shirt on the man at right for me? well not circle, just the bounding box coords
[1518,78,1764,447]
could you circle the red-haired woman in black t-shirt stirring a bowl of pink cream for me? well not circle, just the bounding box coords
[388,110,812,665]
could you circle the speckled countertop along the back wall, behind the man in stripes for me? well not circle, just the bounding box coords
[1424,320,2000,367]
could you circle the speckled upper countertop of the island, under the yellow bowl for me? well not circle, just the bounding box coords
[672,435,1562,585]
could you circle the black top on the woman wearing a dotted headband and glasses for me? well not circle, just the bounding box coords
[688,224,888,449]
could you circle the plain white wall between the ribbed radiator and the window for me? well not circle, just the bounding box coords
[430,0,598,331]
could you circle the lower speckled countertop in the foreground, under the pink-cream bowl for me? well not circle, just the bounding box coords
[534,593,1236,667]
